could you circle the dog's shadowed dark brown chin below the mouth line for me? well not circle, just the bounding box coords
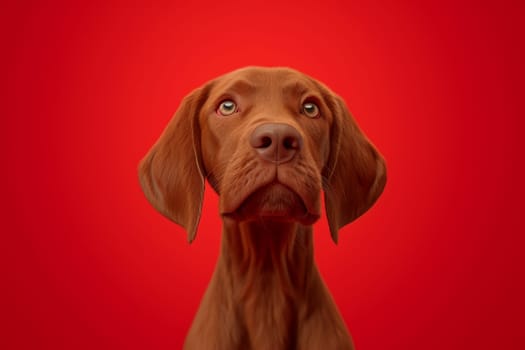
[222,183,319,225]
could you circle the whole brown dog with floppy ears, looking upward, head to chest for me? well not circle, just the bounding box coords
[139,67,386,350]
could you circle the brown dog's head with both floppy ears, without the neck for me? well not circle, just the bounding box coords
[139,67,386,242]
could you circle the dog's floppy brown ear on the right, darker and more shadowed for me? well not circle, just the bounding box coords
[323,94,386,243]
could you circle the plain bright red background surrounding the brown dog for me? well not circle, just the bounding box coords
[0,0,525,350]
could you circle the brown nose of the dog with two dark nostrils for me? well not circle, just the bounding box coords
[250,123,303,164]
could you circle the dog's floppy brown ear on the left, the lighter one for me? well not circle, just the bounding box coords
[139,88,207,243]
